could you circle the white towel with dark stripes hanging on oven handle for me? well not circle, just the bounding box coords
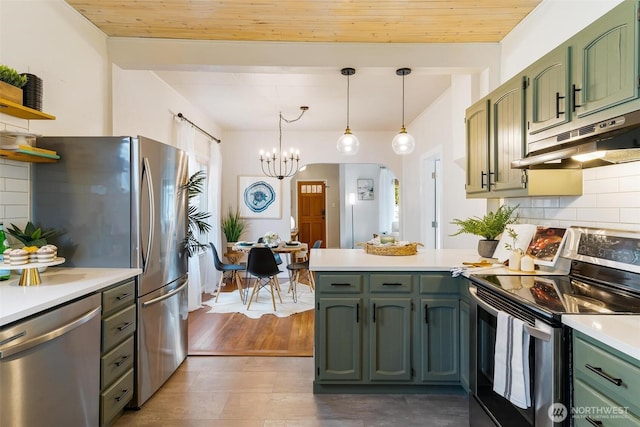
[493,311,531,409]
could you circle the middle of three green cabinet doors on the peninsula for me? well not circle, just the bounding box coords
[369,298,411,381]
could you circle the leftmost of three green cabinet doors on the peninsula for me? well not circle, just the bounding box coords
[315,298,362,380]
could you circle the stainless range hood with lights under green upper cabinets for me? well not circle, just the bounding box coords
[511,111,640,169]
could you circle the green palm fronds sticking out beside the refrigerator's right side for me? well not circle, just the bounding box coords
[182,171,211,258]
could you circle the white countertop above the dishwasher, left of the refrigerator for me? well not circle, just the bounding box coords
[0,267,142,326]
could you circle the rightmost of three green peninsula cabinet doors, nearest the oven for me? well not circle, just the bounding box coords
[419,298,460,383]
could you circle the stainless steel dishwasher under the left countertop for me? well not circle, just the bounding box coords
[0,294,100,427]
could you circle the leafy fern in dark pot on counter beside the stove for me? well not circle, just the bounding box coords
[451,205,519,258]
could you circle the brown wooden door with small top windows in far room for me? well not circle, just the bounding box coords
[298,181,327,248]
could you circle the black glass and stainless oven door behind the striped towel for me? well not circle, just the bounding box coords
[469,283,569,427]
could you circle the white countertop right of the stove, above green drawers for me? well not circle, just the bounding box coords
[562,314,640,361]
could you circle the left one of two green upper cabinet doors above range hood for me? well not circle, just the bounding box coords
[524,45,571,135]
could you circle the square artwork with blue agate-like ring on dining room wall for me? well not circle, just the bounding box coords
[238,176,282,219]
